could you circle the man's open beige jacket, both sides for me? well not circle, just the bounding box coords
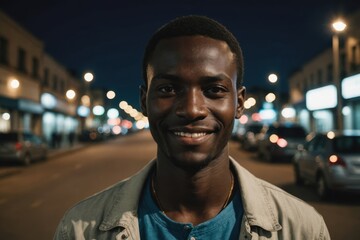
[54,158,330,240]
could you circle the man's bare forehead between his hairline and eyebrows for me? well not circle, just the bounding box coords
[147,36,236,79]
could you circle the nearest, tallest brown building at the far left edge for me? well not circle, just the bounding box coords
[0,12,44,133]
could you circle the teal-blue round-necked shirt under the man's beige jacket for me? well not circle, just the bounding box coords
[138,175,243,240]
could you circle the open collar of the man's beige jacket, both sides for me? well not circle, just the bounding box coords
[99,157,281,231]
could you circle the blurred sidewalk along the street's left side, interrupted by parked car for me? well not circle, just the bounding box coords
[0,142,89,179]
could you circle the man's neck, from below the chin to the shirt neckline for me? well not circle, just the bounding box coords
[152,158,235,225]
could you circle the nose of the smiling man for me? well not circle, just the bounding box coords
[176,89,208,120]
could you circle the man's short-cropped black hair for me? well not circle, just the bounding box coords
[142,15,244,88]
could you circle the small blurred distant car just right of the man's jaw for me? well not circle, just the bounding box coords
[239,122,264,150]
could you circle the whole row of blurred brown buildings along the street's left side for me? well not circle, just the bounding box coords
[0,11,84,146]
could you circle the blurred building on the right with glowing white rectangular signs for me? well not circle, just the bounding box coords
[289,11,360,131]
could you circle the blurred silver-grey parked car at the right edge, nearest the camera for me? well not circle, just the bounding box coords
[293,130,360,199]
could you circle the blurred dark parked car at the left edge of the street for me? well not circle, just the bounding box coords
[0,131,48,165]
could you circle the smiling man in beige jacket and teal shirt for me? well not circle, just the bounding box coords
[55,16,330,240]
